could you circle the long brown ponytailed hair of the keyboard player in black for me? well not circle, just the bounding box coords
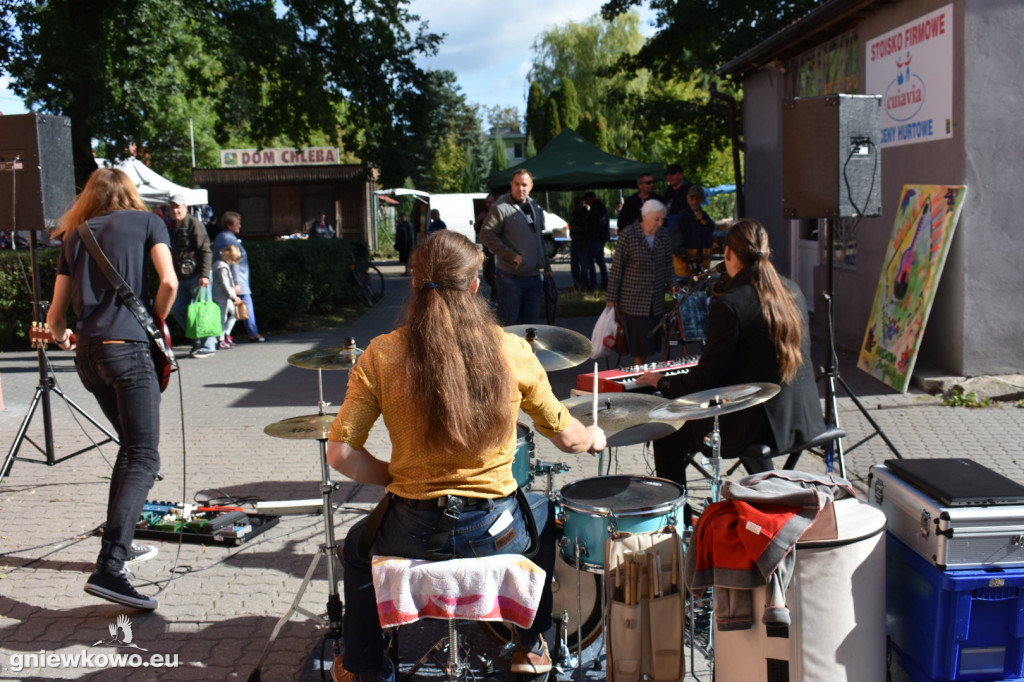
[725,218,804,383]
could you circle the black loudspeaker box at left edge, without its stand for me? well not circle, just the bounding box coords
[0,114,75,231]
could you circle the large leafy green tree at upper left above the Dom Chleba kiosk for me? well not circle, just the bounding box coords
[0,0,441,183]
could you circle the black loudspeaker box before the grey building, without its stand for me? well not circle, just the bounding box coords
[782,94,882,218]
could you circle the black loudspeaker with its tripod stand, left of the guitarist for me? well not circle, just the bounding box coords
[0,114,119,480]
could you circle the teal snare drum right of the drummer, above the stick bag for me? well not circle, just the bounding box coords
[560,476,686,572]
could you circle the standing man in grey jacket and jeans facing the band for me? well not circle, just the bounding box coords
[480,169,553,326]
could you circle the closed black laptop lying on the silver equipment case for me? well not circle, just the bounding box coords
[886,458,1024,507]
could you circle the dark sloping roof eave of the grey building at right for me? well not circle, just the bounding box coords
[715,0,895,77]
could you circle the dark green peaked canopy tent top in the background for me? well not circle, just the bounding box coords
[487,128,663,191]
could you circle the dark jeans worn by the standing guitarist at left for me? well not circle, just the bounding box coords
[75,341,160,573]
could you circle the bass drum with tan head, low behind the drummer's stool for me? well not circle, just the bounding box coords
[480,559,604,657]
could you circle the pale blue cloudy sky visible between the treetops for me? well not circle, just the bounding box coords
[0,0,653,114]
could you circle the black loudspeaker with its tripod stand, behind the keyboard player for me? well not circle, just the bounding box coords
[782,94,902,477]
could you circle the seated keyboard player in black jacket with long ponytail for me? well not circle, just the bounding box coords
[637,219,825,477]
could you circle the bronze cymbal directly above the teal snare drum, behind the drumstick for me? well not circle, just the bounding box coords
[562,393,685,447]
